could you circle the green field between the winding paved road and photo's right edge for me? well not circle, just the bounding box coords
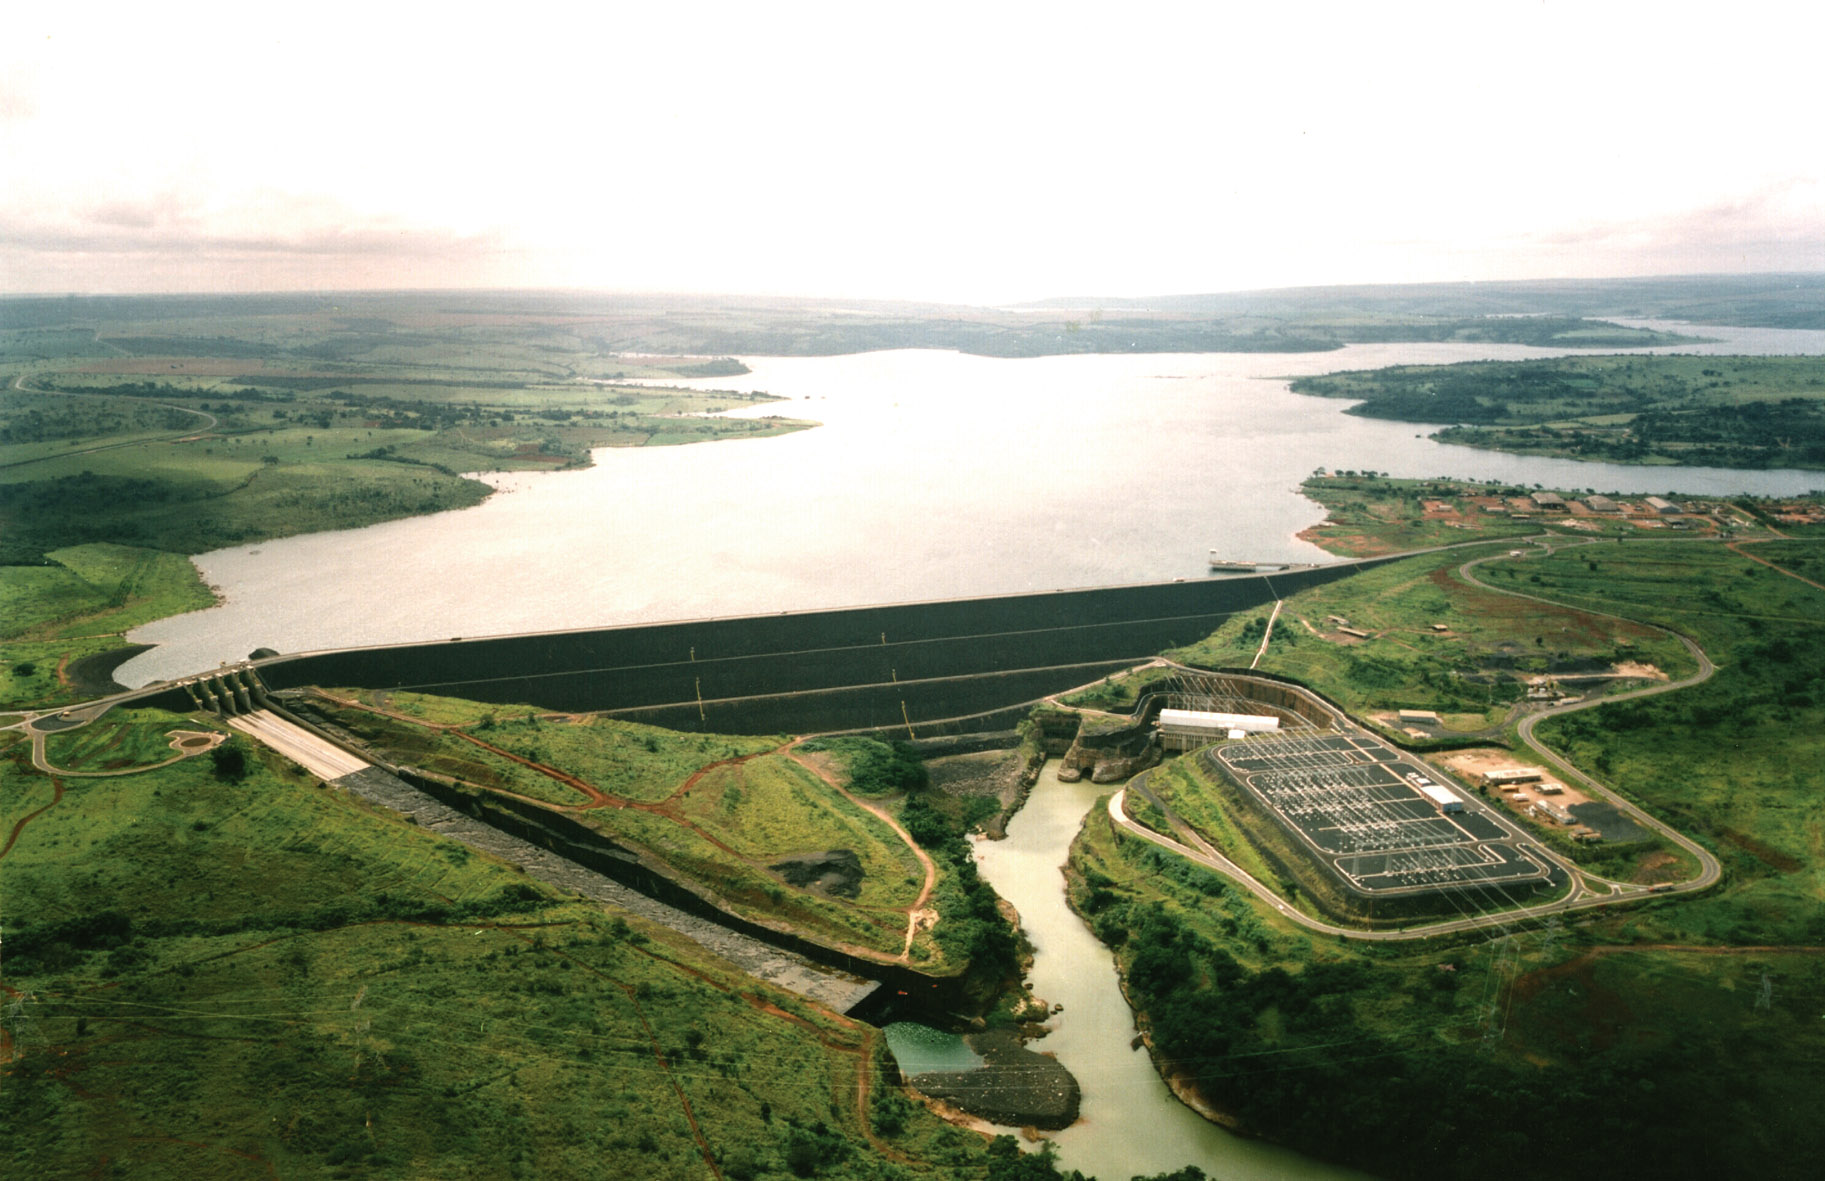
[1518,542,1825,944]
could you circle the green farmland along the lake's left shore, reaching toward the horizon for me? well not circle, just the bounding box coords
[0,313,816,706]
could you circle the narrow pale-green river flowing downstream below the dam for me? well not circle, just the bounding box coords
[976,763,1361,1181]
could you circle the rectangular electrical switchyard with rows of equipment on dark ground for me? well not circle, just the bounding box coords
[1205,730,1548,896]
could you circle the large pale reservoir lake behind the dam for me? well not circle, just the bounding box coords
[119,329,1825,685]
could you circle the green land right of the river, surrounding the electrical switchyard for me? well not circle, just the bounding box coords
[1071,489,1825,1177]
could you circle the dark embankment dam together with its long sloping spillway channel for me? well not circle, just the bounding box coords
[113,559,1392,1020]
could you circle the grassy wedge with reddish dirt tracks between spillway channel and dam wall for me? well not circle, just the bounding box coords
[314,692,934,971]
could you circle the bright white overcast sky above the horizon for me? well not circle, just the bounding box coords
[0,0,1825,303]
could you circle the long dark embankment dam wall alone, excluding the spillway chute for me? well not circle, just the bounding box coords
[133,559,1391,737]
